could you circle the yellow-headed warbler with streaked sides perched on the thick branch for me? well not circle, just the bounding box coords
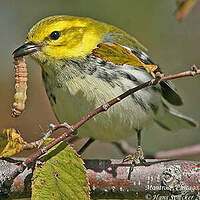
[13,15,197,164]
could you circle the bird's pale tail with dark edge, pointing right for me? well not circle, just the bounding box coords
[155,102,198,131]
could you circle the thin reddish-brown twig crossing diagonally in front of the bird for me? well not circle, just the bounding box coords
[4,66,200,187]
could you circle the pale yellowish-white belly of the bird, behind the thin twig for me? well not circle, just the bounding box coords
[45,72,160,141]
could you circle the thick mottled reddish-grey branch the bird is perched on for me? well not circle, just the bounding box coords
[0,160,200,199]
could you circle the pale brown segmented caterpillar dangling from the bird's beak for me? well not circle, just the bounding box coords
[11,57,28,117]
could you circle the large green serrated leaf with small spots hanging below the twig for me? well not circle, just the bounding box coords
[32,142,90,200]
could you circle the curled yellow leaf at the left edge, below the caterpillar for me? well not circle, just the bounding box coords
[0,129,26,158]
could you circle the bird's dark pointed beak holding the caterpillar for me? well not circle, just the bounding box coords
[13,42,42,58]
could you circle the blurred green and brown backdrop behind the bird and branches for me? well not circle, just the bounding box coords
[0,0,200,159]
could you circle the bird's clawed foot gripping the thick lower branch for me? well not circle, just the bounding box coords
[123,146,147,167]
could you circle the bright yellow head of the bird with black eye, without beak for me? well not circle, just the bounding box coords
[27,16,108,60]
